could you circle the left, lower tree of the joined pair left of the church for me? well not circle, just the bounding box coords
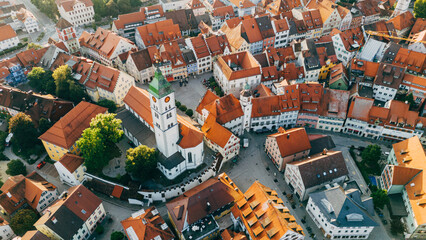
[76,128,105,173]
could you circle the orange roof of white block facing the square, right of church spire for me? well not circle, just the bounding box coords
[217,52,260,81]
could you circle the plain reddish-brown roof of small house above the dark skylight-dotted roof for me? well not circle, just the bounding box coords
[268,128,311,158]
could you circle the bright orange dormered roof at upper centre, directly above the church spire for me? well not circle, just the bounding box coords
[136,19,182,47]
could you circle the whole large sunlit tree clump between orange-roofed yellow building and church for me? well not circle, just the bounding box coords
[77,113,123,172]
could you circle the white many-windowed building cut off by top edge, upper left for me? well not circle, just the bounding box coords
[56,0,95,27]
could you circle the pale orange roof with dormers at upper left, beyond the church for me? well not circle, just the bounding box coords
[79,27,134,58]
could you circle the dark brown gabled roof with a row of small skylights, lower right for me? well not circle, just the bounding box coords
[287,151,349,189]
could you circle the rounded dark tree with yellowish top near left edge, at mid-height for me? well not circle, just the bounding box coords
[9,113,38,149]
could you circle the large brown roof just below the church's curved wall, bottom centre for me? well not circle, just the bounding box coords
[166,173,242,232]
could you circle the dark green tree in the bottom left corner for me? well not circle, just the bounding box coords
[10,209,38,236]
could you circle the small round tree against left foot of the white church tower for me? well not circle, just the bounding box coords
[126,145,158,180]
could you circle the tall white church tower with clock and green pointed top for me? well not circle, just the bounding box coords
[148,68,179,158]
